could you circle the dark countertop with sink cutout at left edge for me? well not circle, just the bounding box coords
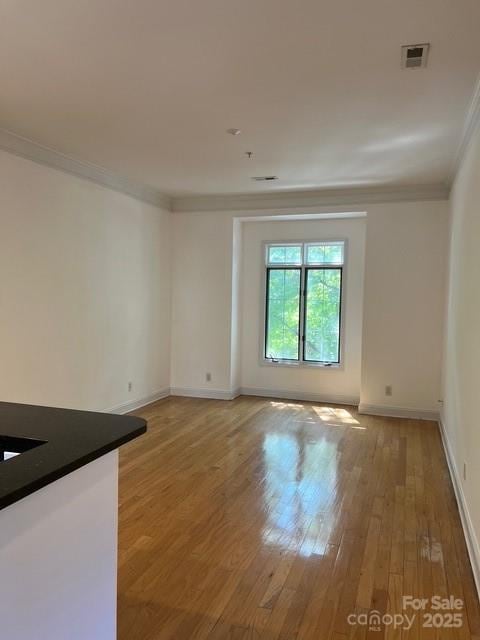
[0,402,147,509]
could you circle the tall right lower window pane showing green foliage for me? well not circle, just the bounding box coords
[304,269,342,362]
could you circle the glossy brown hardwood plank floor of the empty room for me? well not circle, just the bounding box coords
[118,397,480,640]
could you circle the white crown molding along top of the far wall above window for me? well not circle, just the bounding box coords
[172,184,450,212]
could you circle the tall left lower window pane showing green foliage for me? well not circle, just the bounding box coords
[265,269,300,360]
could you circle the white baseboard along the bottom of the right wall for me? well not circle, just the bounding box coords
[438,416,480,598]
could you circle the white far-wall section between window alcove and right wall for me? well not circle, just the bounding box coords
[361,202,448,417]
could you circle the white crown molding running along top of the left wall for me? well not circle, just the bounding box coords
[0,129,172,210]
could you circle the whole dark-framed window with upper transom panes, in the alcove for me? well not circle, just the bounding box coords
[263,241,345,366]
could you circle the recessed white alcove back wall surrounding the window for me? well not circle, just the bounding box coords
[241,218,366,403]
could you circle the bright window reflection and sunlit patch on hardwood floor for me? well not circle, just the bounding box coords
[262,400,367,556]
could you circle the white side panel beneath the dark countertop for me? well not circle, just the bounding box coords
[0,451,118,640]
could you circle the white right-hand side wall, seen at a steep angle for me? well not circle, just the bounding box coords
[442,120,480,589]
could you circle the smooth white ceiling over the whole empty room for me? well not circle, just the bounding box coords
[0,0,480,195]
